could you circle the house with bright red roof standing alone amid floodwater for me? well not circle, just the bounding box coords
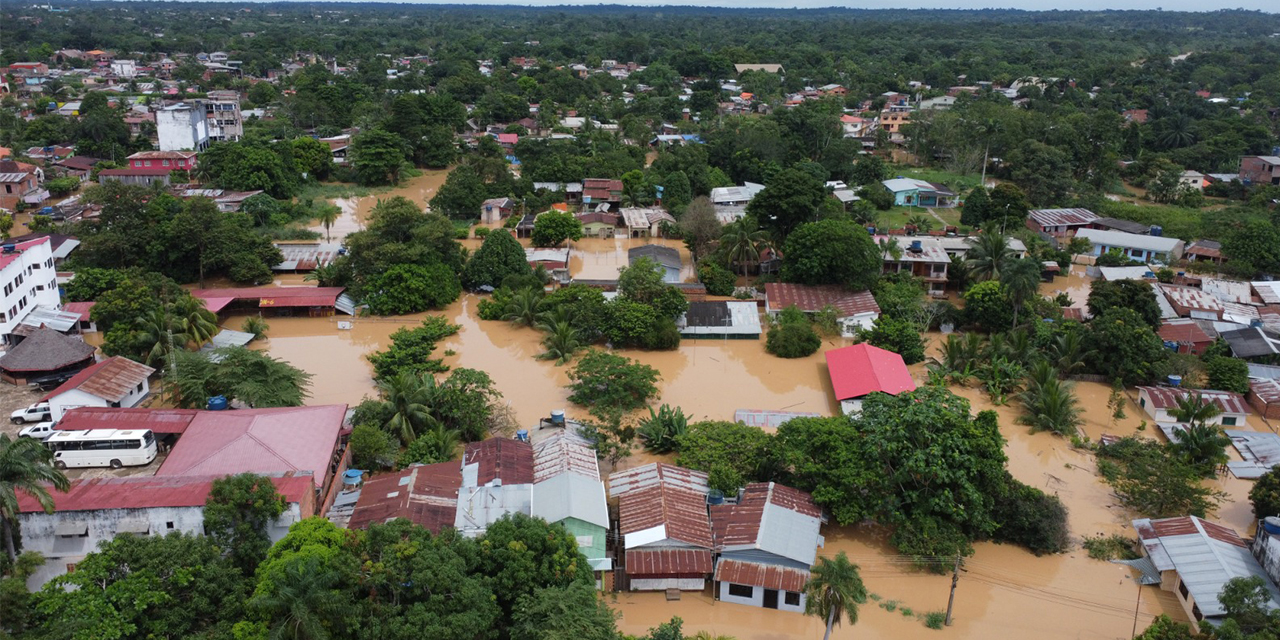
[823,343,915,416]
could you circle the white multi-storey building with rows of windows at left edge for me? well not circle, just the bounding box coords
[0,237,59,343]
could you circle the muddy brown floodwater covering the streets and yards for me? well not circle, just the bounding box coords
[224,172,1270,640]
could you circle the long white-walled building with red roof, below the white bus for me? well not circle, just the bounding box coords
[18,472,315,589]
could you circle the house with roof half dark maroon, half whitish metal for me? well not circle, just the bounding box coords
[453,438,534,538]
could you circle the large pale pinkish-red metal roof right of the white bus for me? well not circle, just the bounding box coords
[156,404,347,486]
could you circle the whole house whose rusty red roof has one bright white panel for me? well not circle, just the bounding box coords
[609,462,716,591]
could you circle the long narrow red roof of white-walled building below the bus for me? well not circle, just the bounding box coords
[18,474,315,513]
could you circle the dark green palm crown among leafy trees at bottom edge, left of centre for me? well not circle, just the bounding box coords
[248,556,347,640]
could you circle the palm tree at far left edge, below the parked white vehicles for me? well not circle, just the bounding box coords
[0,434,70,562]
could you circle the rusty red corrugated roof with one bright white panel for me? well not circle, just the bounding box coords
[609,462,714,549]
